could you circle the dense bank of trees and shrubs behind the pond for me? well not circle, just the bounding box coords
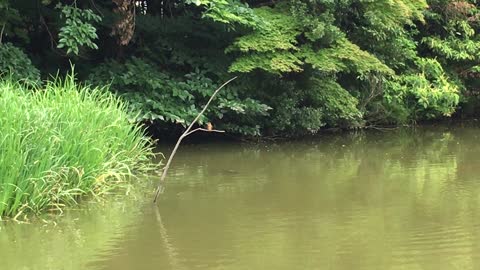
[0,0,480,136]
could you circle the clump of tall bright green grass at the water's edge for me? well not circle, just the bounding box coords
[0,76,153,218]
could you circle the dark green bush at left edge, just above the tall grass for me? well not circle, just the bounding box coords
[0,43,40,84]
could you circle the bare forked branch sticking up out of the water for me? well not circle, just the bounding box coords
[153,77,237,203]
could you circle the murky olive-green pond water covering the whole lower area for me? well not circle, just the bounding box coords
[0,127,480,270]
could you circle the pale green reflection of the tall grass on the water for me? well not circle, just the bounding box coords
[0,196,143,270]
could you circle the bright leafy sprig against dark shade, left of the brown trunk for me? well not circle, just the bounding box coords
[57,4,101,55]
